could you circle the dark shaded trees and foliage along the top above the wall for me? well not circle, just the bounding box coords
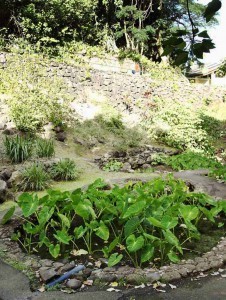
[0,0,221,65]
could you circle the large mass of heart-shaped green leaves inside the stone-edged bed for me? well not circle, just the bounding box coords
[3,176,226,267]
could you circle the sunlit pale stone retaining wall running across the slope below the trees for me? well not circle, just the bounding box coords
[48,63,226,109]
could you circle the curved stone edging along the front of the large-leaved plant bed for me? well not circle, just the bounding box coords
[0,212,226,289]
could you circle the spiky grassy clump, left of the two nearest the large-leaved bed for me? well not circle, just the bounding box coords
[20,164,50,191]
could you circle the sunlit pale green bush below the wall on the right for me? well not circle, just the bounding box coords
[146,99,210,150]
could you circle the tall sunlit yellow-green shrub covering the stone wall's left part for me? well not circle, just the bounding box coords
[0,55,70,132]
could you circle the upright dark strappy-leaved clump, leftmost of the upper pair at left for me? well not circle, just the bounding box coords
[4,135,33,163]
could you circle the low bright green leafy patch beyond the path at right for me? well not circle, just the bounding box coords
[166,151,221,171]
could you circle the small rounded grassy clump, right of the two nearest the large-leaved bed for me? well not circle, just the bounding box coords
[51,158,78,181]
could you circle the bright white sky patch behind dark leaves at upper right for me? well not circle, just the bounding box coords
[197,0,226,63]
